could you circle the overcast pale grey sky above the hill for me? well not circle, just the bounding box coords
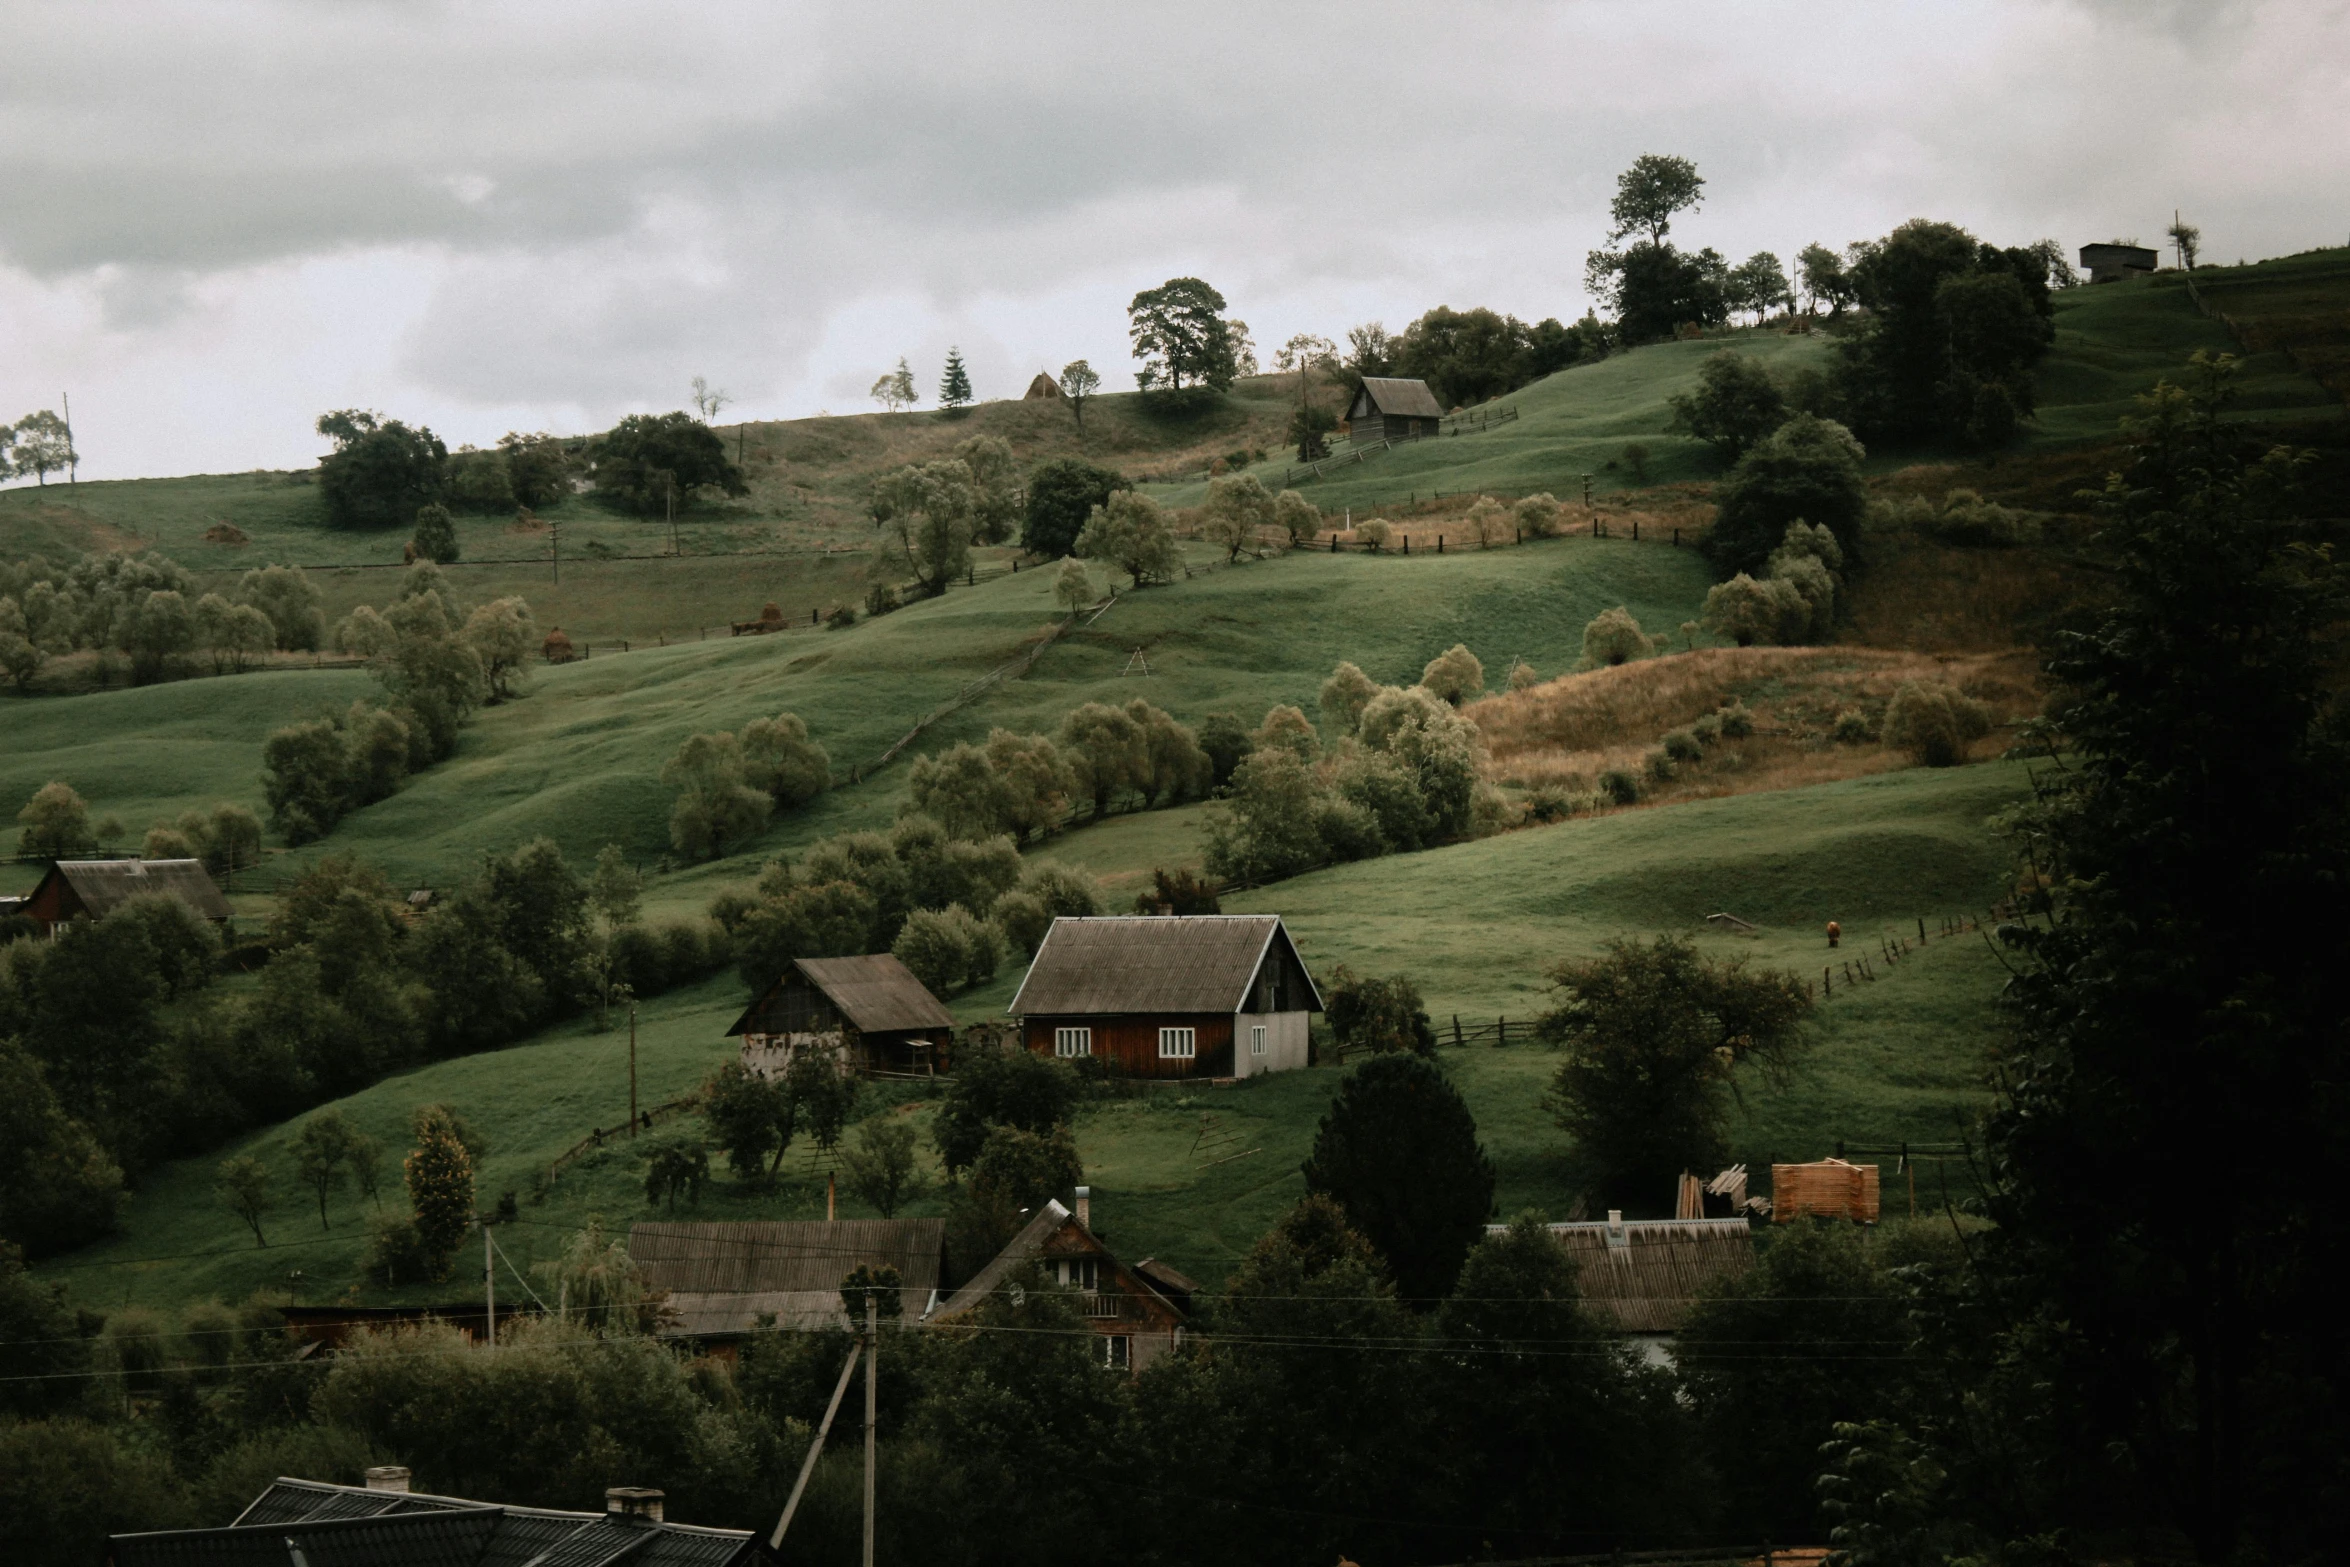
[0,0,2350,479]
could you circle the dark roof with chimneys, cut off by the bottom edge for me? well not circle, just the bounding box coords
[108,1478,759,1567]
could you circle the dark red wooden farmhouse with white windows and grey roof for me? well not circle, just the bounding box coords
[1008,914,1323,1078]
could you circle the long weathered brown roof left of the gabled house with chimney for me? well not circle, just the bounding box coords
[627,1219,947,1339]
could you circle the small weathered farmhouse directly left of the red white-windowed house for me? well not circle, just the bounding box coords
[726,951,954,1076]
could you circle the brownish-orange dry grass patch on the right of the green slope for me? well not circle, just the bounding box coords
[1464,646,2040,801]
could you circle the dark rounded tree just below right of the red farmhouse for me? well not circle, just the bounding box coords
[1304,1050,1495,1309]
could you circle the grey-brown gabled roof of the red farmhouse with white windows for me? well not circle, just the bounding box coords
[1006,914,1321,1017]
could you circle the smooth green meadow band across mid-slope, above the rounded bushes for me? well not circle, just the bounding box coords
[0,538,1706,897]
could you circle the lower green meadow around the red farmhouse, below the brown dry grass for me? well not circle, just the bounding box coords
[45,764,2023,1306]
